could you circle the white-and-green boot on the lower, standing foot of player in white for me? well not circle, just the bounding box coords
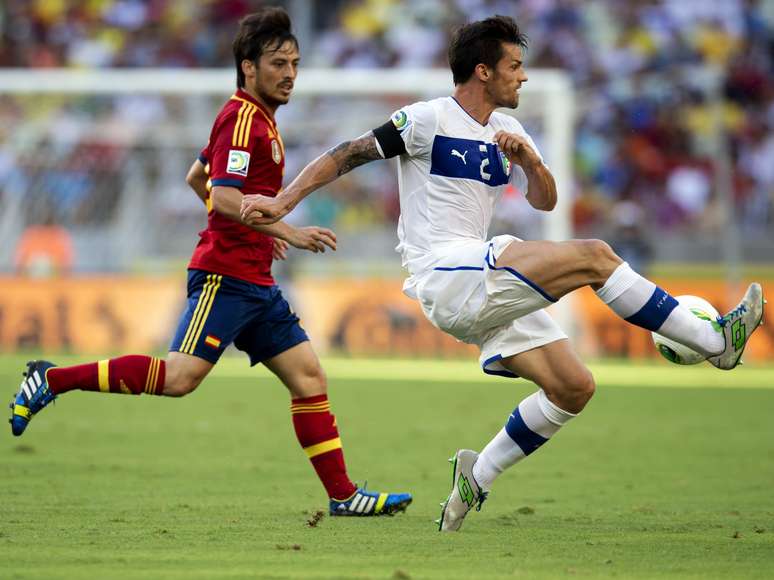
[436,449,489,532]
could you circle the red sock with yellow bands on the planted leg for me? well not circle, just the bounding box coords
[290,395,357,499]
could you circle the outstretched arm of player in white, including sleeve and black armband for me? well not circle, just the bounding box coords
[242,103,438,225]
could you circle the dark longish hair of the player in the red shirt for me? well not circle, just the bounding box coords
[232,6,298,88]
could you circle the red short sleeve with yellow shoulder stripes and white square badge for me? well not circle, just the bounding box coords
[208,112,252,189]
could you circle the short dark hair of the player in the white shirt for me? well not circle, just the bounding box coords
[449,15,527,85]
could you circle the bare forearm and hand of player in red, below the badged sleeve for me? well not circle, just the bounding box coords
[210,186,336,253]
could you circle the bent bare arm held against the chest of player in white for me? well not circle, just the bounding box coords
[494,131,557,211]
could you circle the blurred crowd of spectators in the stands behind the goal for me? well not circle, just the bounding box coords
[0,0,774,270]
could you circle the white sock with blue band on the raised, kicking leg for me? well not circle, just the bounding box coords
[597,262,725,356]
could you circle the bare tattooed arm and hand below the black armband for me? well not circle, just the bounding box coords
[241,131,384,226]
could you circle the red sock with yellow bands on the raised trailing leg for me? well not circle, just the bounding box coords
[46,354,166,395]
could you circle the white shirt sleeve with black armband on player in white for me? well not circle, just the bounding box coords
[374,102,438,157]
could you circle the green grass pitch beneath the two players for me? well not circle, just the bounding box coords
[0,357,774,579]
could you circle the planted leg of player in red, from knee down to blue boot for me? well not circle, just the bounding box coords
[264,341,412,516]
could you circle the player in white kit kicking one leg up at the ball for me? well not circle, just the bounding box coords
[242,16,764,531]
